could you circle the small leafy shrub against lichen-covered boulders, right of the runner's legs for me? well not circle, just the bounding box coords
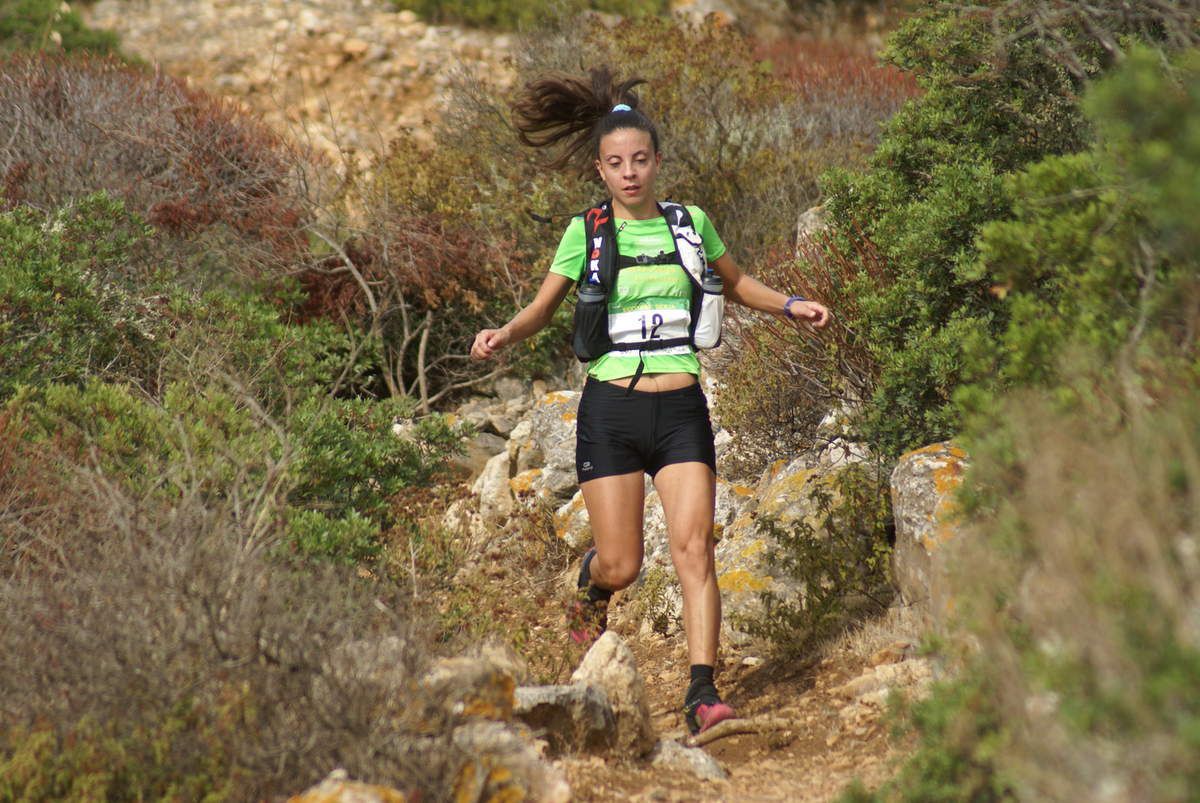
[740,463,892,654]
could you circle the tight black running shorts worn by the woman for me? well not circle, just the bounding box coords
[575,377,716,484]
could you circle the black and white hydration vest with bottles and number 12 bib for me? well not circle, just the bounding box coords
[571,200,725,362]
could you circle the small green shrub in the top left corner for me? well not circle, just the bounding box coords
[0,0,118,55]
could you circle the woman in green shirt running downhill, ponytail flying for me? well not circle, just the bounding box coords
[470,68,829,733]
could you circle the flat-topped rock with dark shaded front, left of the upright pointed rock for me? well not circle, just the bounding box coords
[514,684,617,754]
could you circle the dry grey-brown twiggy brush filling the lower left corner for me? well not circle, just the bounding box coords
[0,420,457,801]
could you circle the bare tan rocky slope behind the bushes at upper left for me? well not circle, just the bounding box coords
[80,0,511,160]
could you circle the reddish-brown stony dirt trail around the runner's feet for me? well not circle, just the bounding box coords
[549,592,930,803]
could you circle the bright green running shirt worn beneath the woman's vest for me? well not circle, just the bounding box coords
[550,206,725,382]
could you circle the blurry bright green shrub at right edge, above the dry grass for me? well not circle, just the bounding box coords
[958,49,1200,418]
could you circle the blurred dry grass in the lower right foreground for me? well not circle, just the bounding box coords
[940,382,1200,799]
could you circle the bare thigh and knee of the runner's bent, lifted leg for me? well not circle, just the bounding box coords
[580,467,648,591]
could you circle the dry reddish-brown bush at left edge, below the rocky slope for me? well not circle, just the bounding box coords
[0,55,308,280]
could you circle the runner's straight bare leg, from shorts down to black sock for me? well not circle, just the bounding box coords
[654,462,721,666]
